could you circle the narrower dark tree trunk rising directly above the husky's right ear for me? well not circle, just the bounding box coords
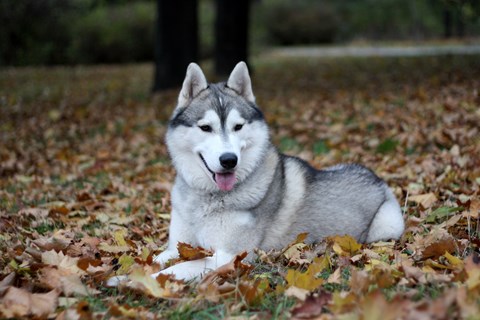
[214,0,250,76]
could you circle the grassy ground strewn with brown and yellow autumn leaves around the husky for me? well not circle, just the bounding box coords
[0,56,480,319]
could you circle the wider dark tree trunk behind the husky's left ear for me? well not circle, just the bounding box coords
[153,0,198,91]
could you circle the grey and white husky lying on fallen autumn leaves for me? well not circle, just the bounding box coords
[152,62,404,279]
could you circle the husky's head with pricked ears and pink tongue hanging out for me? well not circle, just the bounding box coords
[167,62,269,192]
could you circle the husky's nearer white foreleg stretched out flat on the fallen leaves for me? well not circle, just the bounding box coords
[152,250,235,280]
